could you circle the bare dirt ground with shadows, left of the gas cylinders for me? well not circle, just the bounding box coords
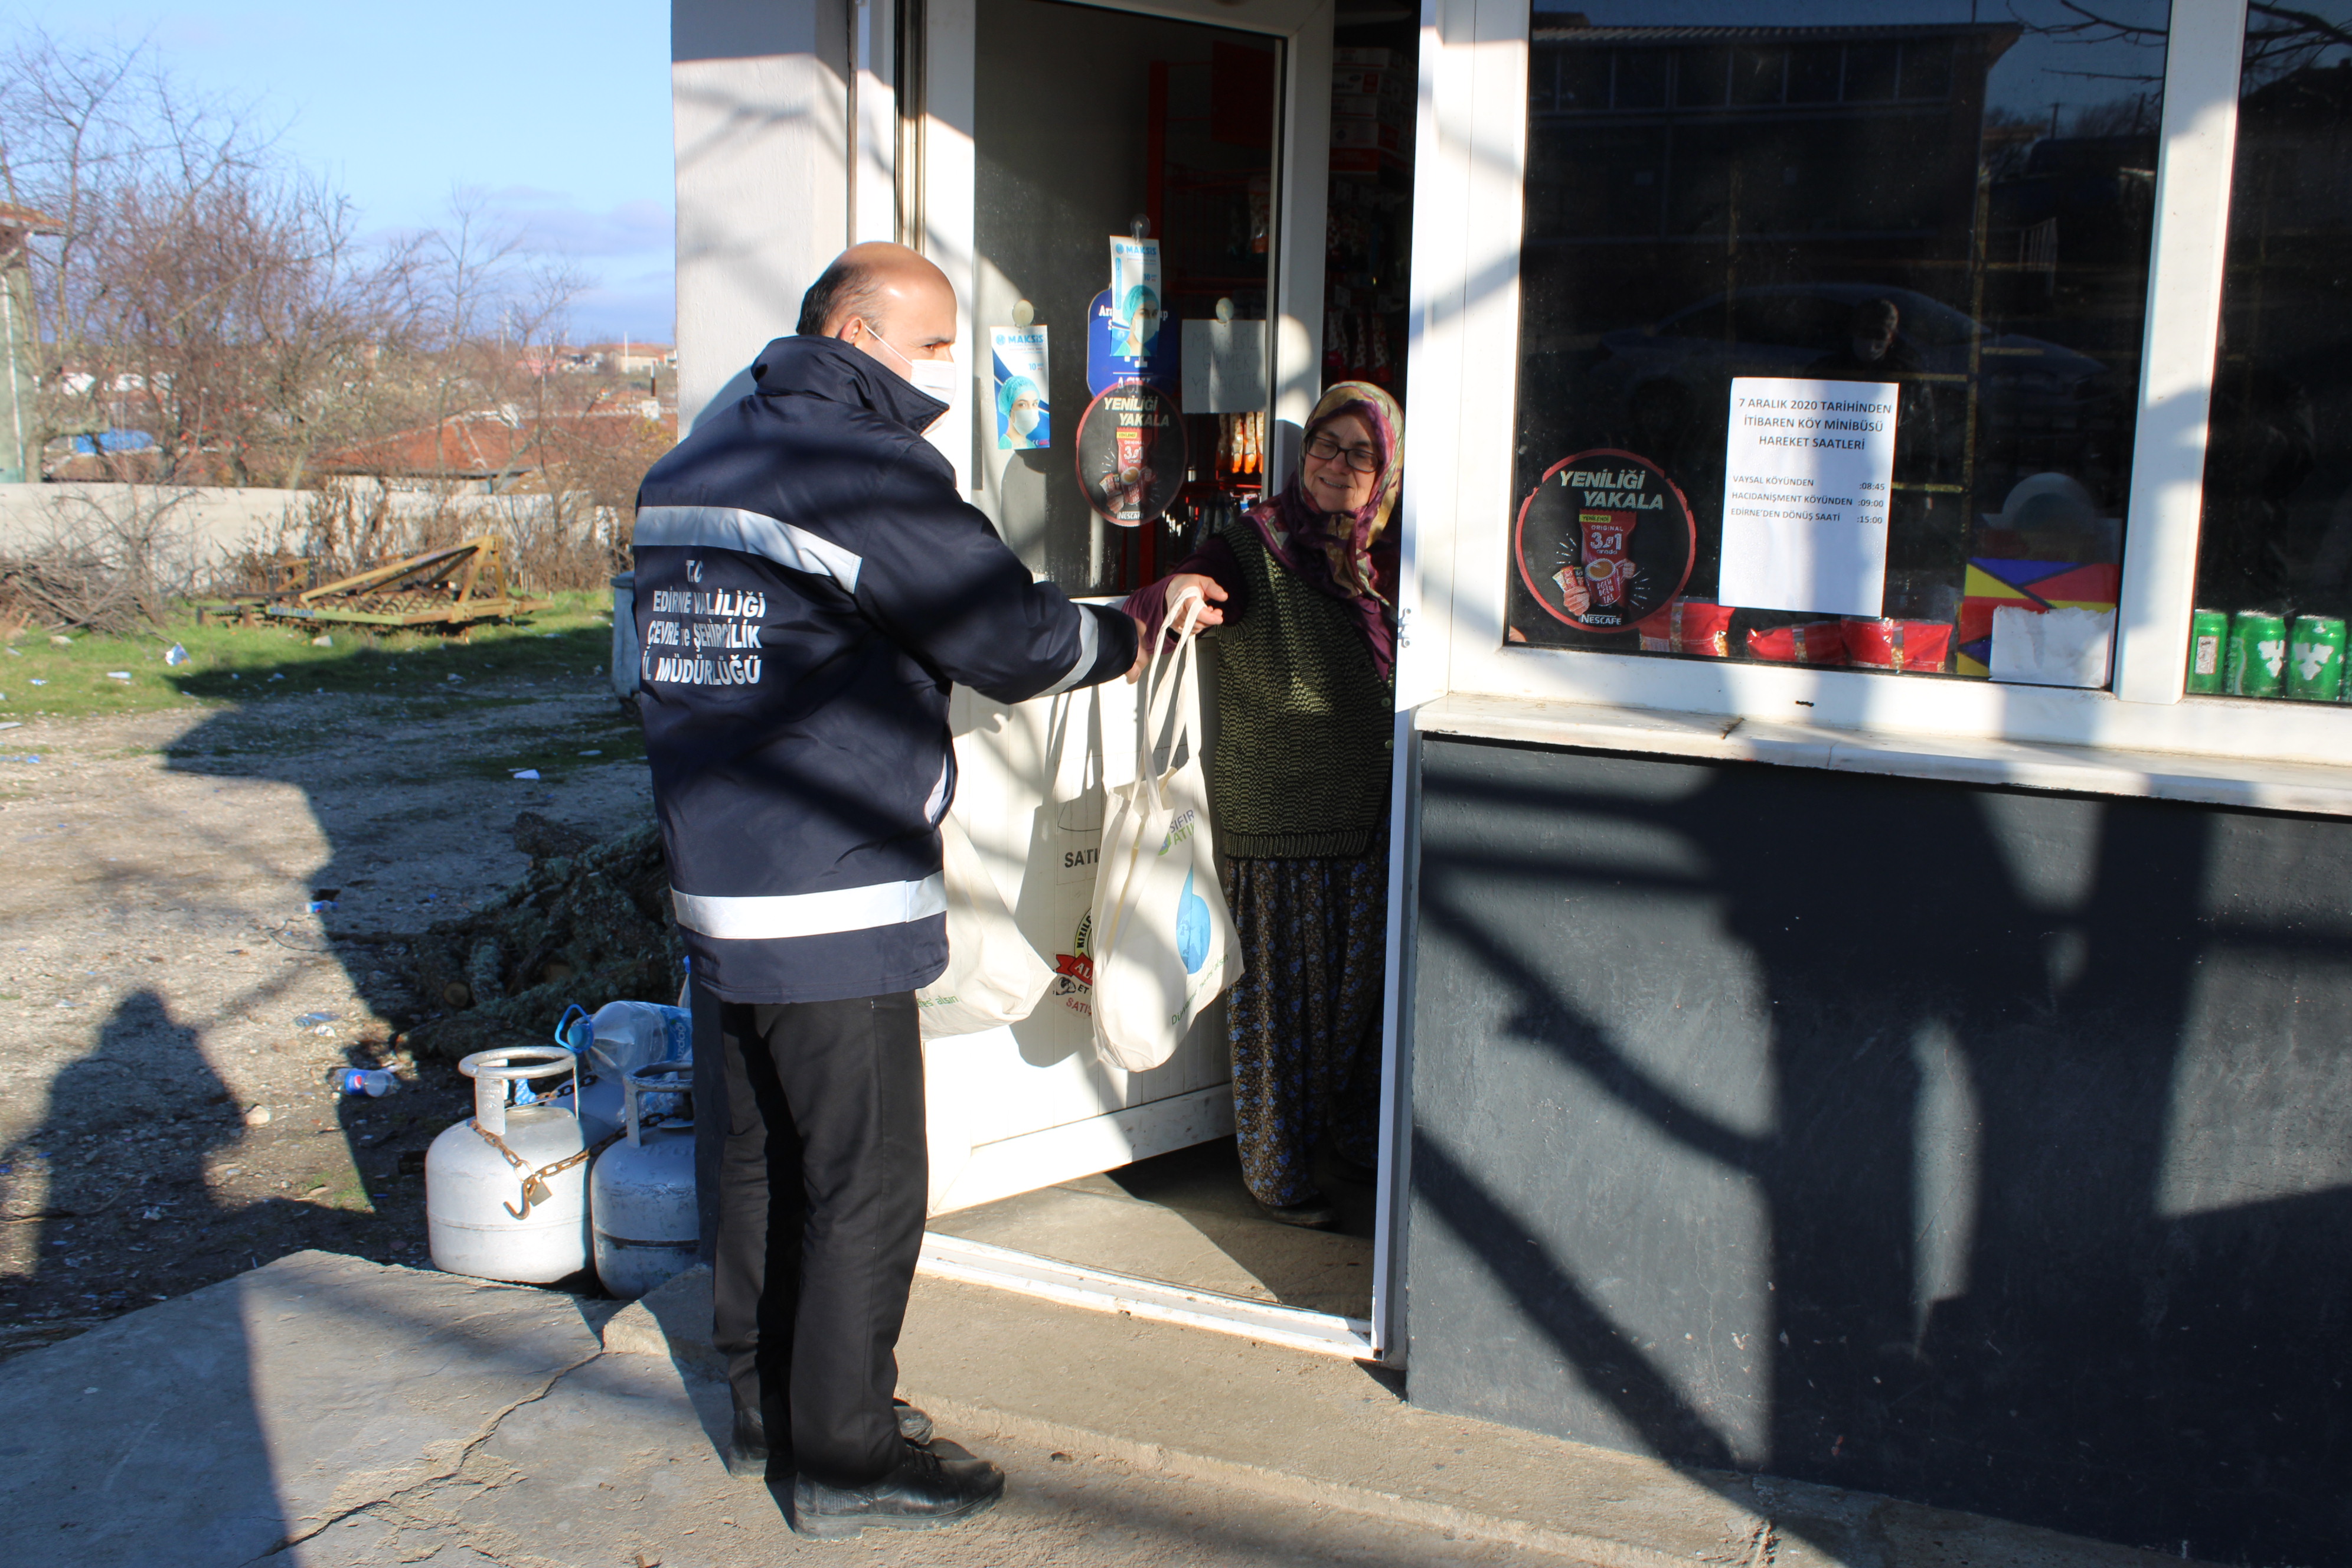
[0,670,652,1357]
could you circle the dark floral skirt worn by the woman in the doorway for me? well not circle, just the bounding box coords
[1226,835,1388,1208]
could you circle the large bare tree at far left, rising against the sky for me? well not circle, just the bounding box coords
[0,33,430,484]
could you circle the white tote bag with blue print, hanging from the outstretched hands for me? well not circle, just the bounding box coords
[1094,599,1242,1072]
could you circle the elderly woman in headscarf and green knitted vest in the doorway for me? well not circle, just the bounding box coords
[1126,381,1404,1230]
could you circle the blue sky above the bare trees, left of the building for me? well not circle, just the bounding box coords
[0,0,675,341]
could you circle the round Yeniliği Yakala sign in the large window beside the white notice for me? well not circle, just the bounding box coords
[1510,447,1698,632]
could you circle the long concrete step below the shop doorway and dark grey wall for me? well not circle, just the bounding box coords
[605,1269,2180,1568]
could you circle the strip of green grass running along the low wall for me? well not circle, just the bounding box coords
[0,590,612,719]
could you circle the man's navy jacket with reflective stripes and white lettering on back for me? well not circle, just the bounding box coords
[635,336,1136,1001]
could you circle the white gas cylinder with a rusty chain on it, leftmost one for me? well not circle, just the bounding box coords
[426,1046,588,1286]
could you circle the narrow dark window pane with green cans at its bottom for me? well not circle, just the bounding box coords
[2187,0,2352,701]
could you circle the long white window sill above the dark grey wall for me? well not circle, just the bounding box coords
[1413,694,2352,816]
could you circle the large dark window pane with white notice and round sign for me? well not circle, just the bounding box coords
[1505,0,2164,687]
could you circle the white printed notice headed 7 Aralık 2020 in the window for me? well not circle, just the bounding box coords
[1717,376,1896,618]
